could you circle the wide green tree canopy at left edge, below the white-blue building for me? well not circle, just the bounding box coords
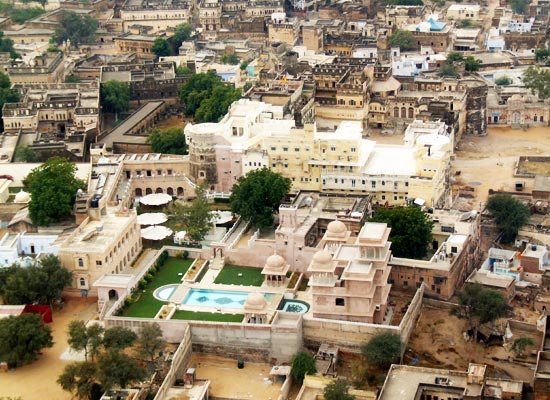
[0,254,73,304]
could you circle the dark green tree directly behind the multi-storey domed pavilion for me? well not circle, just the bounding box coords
[371,206,433,260]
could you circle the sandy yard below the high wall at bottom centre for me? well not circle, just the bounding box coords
[190,353,281,400]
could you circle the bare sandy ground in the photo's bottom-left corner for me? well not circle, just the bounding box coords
[0,299,97,400]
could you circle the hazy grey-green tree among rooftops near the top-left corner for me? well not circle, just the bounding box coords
[53,10,98,47]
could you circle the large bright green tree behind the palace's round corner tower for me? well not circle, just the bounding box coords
[180,71,241,122]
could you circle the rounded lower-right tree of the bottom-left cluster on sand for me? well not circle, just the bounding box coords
[97,351,145,391]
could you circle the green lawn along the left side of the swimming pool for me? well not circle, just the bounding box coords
[123,257,193,318]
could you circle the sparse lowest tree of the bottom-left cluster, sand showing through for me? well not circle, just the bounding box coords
[57,361,97,400]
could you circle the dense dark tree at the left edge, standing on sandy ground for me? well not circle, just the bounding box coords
[0,314,53,367]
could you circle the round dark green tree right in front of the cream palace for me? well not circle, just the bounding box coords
[229,167,291,227]
